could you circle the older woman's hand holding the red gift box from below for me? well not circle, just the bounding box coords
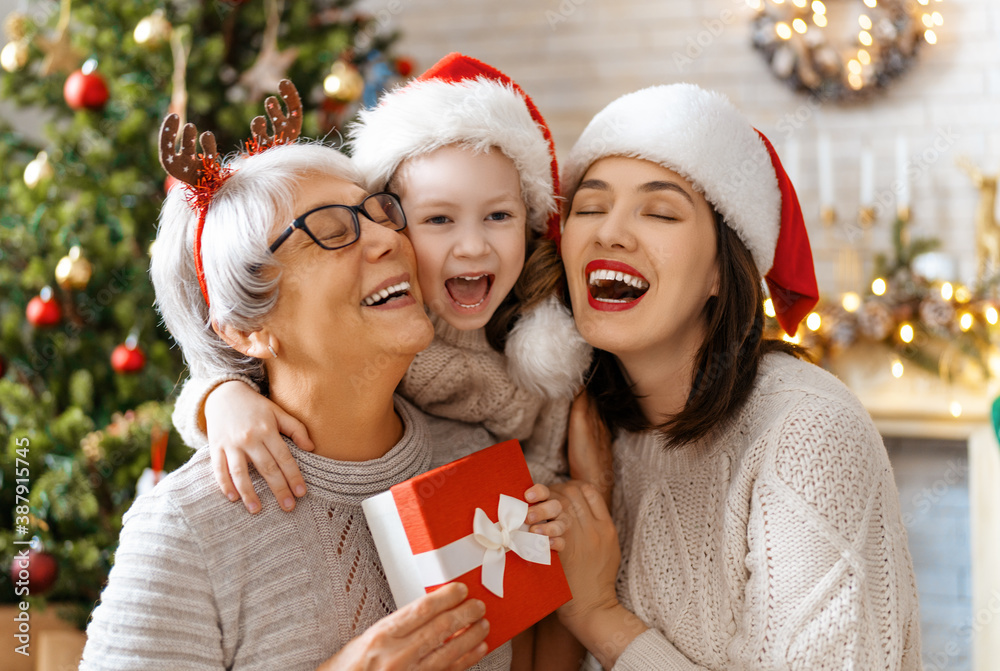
[317,583,490,671]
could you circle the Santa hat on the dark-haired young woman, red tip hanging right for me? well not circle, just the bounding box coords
[563,84,819,335]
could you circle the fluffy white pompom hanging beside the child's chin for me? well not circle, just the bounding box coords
[504,296,593,399]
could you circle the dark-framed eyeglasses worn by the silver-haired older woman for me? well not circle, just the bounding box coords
[271,192,406,254]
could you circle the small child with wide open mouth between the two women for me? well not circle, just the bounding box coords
[174,54,590,512]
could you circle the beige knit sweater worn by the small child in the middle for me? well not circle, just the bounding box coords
[173,314,571,484]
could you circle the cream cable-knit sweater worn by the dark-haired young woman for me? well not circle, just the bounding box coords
[591,354,921,671]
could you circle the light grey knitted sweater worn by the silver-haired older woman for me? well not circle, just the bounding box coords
[80,397,510,671]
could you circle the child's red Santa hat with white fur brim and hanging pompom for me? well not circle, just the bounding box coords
[348,53,591,398]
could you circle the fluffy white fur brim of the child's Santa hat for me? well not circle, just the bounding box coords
[348,77,556,234]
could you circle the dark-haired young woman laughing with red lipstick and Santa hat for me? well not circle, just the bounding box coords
[560,84,921,671]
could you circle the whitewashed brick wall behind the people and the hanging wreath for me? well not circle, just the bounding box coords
[367,0,1000,294]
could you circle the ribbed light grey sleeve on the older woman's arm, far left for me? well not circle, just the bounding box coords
[80,488,225,671]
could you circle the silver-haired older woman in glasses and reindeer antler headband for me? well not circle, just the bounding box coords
[81,97,558,670]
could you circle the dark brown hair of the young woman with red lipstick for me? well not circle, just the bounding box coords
[587,212,806,448]
